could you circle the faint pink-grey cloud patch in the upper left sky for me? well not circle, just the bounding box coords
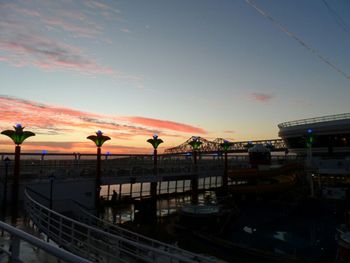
[0,0,138,80]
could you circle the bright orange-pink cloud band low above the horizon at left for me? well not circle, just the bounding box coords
[0,95,206,153]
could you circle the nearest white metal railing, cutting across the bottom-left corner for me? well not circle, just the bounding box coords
[0,221,91,263]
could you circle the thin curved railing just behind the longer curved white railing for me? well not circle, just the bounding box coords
[74,202,222,263]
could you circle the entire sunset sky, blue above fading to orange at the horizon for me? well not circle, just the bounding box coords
[0,0,350,153]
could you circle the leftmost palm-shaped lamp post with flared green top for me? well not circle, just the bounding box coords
[1,124,35,224]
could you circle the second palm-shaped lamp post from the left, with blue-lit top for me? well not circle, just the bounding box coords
[87,130,111,211]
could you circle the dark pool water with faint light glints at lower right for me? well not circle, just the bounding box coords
[228,202,341,262]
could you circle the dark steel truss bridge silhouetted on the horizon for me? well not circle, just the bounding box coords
[165,137,287,154]
